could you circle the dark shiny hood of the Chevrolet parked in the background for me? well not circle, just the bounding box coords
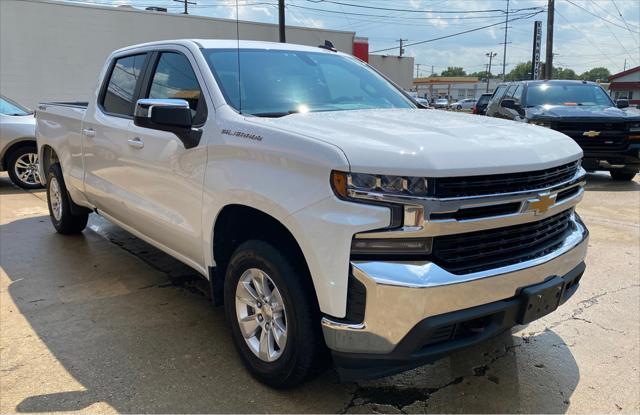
[527,105,640,121]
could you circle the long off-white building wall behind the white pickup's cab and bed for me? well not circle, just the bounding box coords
[0,0,356,108]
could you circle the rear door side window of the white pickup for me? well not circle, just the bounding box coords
[101,53,147,117]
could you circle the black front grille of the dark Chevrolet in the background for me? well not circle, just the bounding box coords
[553,122,627,152]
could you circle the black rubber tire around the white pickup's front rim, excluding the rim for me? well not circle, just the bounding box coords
[224,240,327,388]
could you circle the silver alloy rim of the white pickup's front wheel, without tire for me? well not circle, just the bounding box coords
[236,268,287,362]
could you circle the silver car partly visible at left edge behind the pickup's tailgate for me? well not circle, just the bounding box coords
[0,95,41,189]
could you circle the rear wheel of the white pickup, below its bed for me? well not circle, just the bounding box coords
[47,163,89,235]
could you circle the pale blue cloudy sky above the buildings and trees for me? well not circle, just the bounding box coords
[62,0,640,75]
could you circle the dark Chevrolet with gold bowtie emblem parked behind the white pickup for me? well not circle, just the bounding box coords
[486,81,640,180]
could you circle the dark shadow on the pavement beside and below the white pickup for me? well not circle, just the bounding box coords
[0,213,579,413]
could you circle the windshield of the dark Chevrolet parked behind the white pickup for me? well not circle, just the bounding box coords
[527,84,613,107]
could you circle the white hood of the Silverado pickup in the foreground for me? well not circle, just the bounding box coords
[252,109,582,177]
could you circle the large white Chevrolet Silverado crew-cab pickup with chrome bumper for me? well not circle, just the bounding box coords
[36,40,588,387]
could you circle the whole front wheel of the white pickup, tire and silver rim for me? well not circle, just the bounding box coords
[224,240,325,388]
